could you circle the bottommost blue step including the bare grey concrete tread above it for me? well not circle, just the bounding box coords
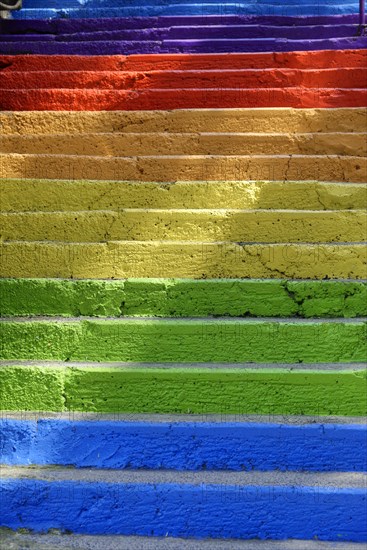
[1,467,367,542]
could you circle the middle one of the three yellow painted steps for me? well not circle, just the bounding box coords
[0,209,367,243]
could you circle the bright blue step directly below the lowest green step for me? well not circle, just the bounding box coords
[0,412,367,472]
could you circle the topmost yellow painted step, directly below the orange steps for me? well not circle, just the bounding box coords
[0,179,367,212]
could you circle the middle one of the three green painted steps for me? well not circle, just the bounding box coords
[0,318,367,363]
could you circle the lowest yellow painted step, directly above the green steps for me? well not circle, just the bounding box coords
[0,241,367,279]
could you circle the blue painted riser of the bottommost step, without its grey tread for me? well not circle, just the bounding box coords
[1,479,366,541]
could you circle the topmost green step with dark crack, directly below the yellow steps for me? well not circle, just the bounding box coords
[0,279,367,317]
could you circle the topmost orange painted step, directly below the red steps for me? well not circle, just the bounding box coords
[0,108,367,135]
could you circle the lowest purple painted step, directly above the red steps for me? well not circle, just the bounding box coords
[0,36,367,55]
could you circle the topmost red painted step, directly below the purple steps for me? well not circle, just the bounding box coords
[0,50,367,71]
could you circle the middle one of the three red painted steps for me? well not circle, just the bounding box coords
[0,68,367,91]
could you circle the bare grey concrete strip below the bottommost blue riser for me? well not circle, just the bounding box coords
[0,529,365,550]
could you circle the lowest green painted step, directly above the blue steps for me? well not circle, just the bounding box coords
[0,361,367,416]
